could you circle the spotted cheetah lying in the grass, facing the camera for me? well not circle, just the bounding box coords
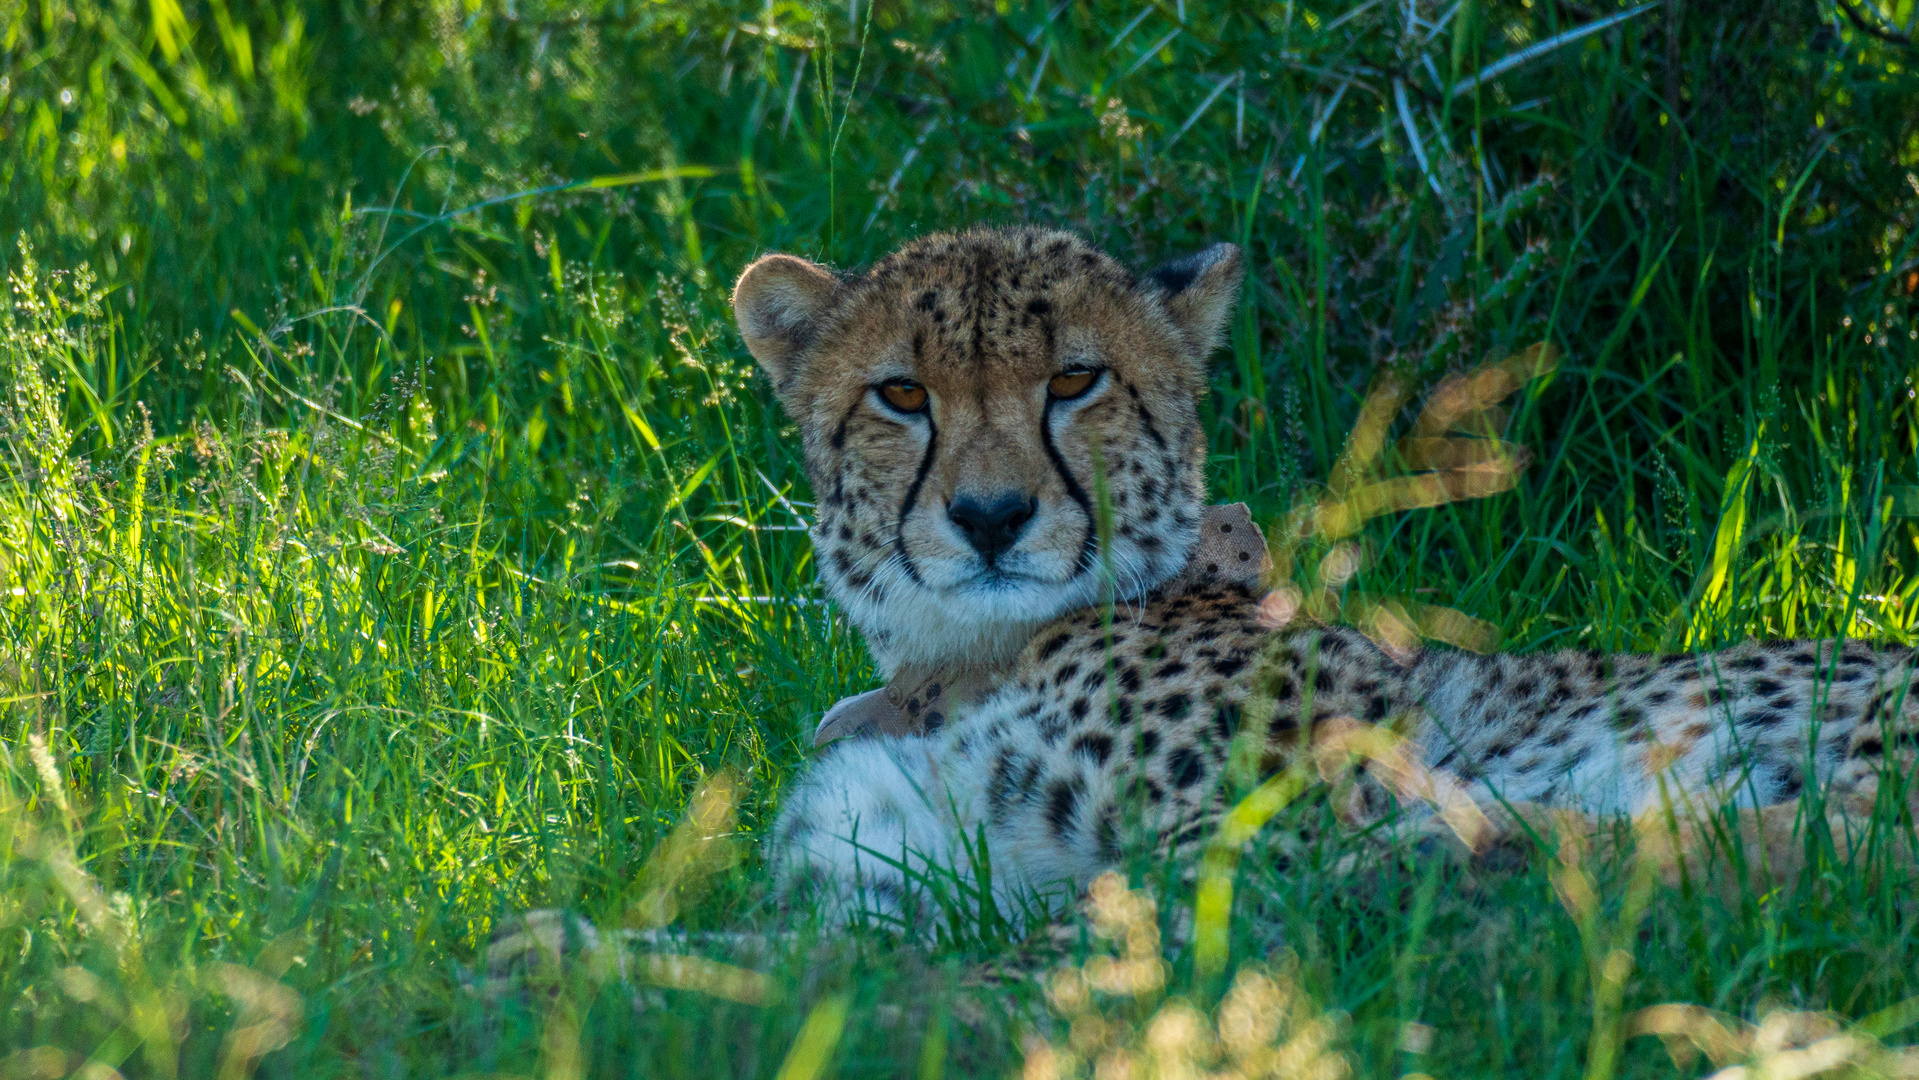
[733,228,1919,919]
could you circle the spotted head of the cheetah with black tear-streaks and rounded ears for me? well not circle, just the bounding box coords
[733,228,1240,671]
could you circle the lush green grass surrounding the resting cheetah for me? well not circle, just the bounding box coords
[0,0,1919,1080]
